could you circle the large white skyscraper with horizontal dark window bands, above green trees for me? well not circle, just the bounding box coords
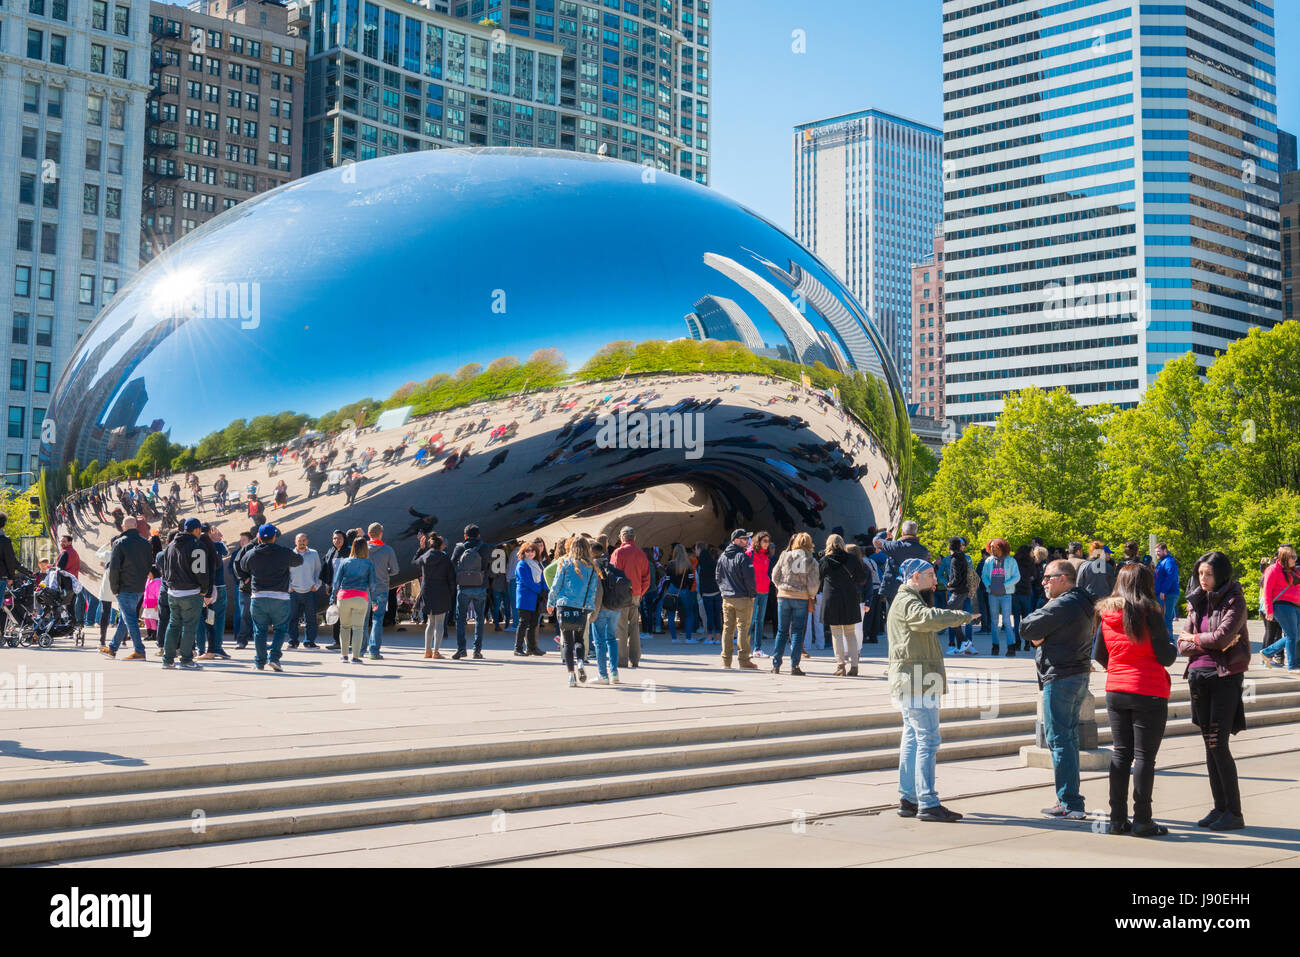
[943,0,1282,424]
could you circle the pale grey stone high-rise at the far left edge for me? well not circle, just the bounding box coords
[0,0,150,485]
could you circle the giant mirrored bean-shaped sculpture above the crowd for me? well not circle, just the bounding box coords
[40,150,910,580]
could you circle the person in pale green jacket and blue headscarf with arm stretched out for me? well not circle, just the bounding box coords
[885,558,979,822]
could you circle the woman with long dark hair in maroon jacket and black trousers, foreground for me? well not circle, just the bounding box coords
[1178,549,1248,831]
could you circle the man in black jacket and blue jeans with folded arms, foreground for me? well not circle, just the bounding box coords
[1021,560,1093,820]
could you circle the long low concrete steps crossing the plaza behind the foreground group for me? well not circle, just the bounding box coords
[0,697,1300,865]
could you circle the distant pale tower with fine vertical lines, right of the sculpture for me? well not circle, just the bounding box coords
[793,109,943,389]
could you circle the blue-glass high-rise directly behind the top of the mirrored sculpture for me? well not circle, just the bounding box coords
[299,0,711,185]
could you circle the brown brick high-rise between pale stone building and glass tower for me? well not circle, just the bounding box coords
[140,0,307,260]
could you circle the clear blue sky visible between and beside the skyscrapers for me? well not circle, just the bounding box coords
[710,0,1300,230]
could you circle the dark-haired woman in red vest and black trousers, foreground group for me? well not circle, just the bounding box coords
[1092,563,1178,837]
